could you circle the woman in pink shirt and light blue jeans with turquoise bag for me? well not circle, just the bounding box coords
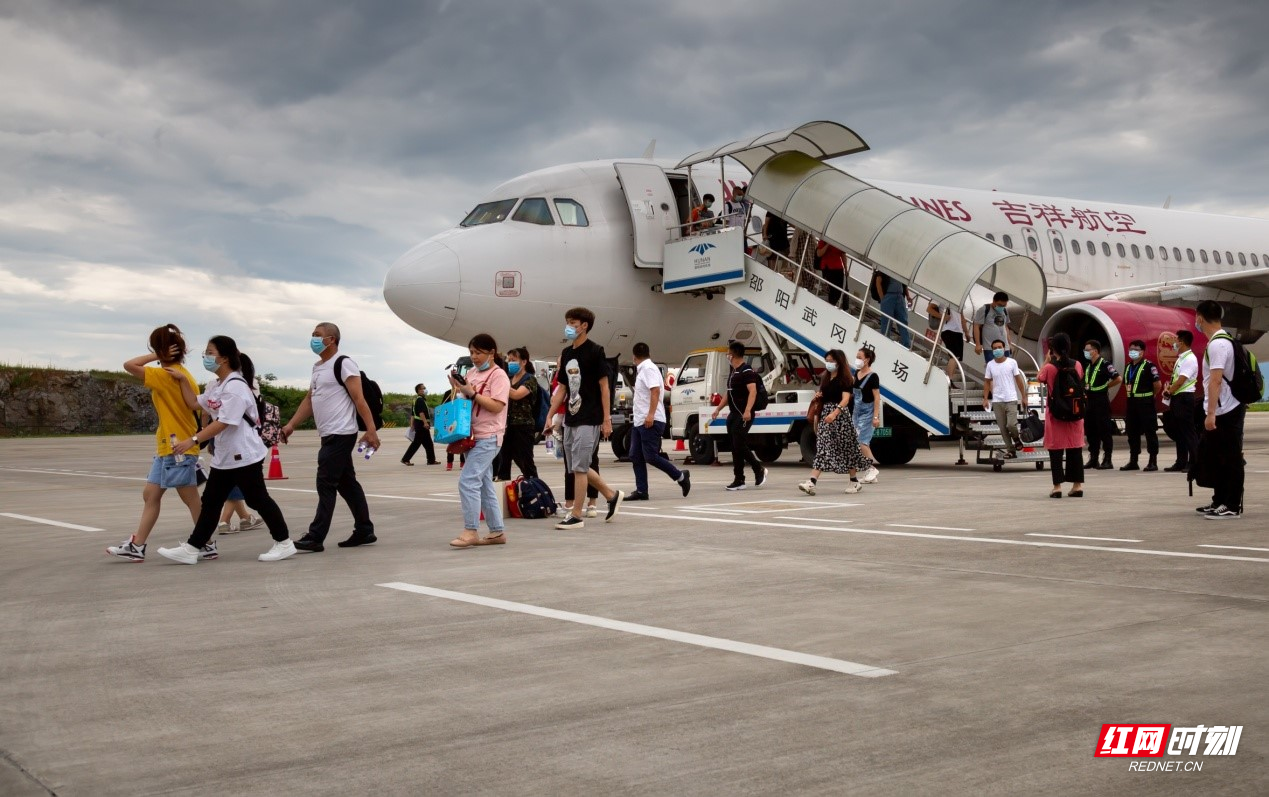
[449,333,511,548]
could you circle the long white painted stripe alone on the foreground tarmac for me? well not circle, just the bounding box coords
[376,581,897,678]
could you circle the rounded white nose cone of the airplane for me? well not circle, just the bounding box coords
[383,241,459,338]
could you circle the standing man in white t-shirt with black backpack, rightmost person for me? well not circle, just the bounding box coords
[1194,300,1247,520]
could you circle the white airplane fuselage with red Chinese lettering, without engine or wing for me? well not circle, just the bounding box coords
[383,159,1269,363]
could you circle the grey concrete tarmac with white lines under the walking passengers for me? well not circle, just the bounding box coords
[0,415,1269,797]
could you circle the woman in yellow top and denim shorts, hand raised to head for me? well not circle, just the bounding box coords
[105,324,208,562]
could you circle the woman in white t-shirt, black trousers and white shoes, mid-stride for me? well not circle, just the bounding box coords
[159,335,296,565]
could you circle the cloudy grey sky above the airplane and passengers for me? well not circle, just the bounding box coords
[0,0,1269,390]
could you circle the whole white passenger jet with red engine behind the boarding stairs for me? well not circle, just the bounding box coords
[383,122,1269,413]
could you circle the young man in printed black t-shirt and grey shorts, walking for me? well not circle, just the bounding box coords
[547,307,624,529]
